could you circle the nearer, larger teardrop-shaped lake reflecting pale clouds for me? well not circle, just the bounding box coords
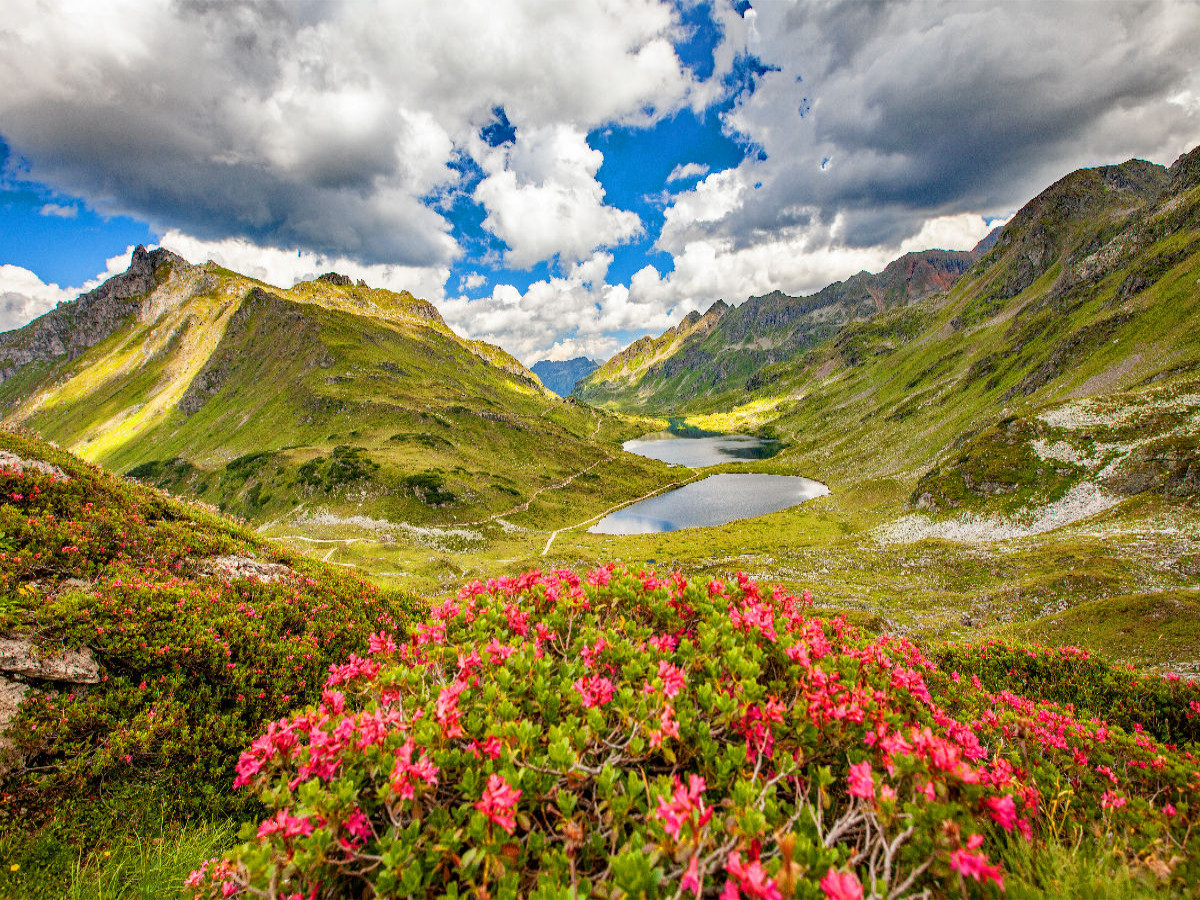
[588,474,829,534]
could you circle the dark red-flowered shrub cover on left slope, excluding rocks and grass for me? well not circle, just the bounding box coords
[0,433,422,822]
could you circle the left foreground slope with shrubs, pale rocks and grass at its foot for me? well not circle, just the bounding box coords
[0,431,424,898]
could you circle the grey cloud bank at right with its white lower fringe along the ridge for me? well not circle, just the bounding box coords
[630,1,1200,316]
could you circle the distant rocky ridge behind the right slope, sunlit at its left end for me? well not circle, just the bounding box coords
[576,250,977,414]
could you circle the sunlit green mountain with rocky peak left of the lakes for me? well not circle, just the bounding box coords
[0,247,672,542]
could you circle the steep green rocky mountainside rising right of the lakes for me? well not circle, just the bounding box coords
[706,150,1200,513]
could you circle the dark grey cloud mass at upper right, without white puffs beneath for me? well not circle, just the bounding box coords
[697,1,1200,246]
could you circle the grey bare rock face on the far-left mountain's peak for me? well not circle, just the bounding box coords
[0,246,194,383]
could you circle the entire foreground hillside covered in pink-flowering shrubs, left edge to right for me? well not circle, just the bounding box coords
[0,424,1196,900]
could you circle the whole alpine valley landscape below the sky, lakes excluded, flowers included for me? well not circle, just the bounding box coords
[0,144,1200,898]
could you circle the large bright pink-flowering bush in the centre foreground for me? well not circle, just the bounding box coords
[188,566,1195,900]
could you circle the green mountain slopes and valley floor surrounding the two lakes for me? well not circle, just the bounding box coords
[0,151,1200,640]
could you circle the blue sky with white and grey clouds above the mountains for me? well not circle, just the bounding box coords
[0,0,1200,365]
